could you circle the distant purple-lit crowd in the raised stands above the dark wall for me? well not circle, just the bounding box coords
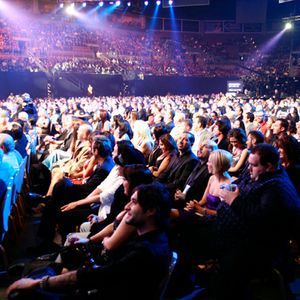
[0,17,297,81]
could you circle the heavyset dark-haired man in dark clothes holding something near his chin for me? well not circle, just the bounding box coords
[215,144,300,299]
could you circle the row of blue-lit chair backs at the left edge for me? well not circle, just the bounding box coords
[0,157,28,274]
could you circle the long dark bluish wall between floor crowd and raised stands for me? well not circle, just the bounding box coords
[0,72,236,99]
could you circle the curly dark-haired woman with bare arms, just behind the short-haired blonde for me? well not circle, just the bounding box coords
[228,128,249,177]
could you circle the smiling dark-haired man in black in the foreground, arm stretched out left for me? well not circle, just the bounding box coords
[7,183,171,300]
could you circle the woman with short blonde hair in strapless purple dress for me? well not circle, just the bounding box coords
[170,149,232,267]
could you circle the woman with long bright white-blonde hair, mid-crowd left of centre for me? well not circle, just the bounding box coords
[131,120,154,161]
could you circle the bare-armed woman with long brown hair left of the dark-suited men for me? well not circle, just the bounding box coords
[149,133,178,177]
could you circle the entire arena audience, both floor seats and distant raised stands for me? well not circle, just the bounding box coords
[0,3,300,299]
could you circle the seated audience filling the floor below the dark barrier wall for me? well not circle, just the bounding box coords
[0,90,300,299]
